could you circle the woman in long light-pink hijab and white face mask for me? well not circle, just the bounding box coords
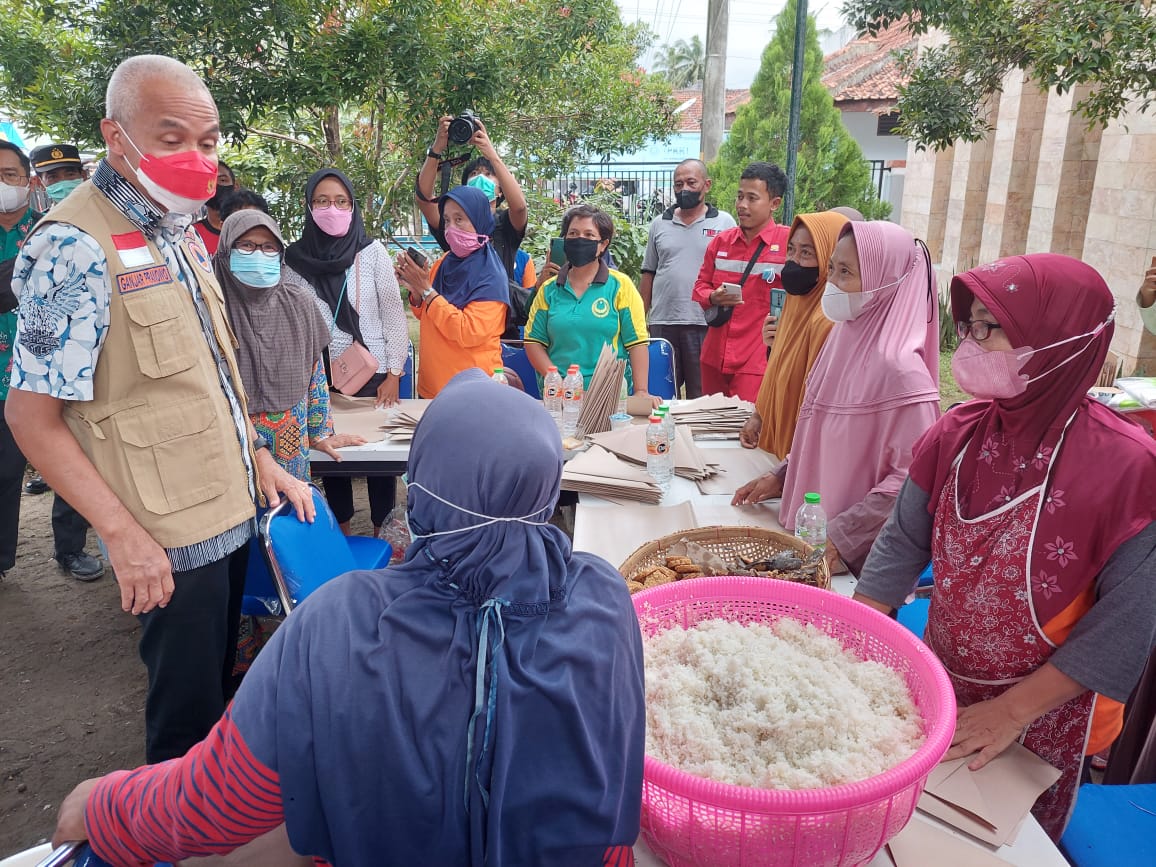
[732,222,940,575]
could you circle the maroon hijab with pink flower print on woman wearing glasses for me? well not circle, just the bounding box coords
[911,253,1156,624]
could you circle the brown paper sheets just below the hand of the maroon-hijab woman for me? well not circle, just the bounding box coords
[919,743,1060,846]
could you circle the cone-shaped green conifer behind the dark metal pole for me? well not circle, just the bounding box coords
[711,0,891,218]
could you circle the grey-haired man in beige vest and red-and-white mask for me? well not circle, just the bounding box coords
[8,55,312,763]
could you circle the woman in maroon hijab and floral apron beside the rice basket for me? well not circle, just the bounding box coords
[855,254,1156,839]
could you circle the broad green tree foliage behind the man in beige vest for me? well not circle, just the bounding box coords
[0,0,674,234]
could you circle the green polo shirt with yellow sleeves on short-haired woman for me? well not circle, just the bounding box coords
[526,264,650,386]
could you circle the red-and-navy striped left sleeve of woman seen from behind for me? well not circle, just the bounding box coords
[84,709,284,867]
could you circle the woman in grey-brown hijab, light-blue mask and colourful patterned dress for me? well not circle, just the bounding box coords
[213,210,364,482]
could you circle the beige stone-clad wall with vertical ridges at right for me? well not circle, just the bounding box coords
[902,72,1156,376]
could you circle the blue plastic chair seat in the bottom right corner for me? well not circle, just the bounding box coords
[1060,783,1156,867]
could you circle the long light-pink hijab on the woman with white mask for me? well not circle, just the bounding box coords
[779,221,939,532]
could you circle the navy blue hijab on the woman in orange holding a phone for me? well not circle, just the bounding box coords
[434,186,510,309]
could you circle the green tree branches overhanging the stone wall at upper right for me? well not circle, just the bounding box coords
[844,0,1156,150]
